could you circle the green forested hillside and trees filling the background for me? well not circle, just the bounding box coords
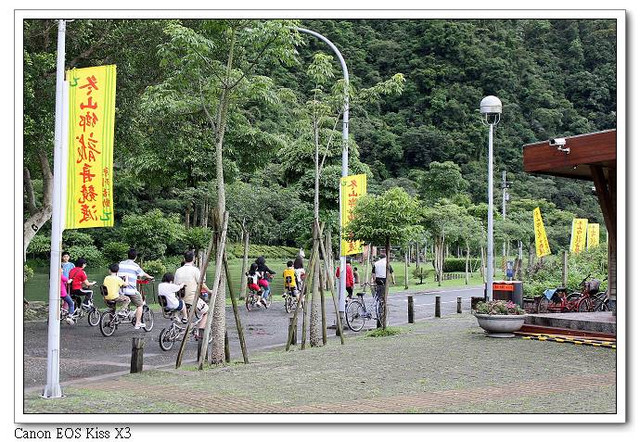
[23,19,617,258]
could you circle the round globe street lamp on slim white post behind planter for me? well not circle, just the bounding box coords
[480,95,502,301]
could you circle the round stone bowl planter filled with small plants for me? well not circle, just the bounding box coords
[473,300,527,338]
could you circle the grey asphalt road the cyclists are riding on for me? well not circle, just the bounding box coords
[23,287,482,391]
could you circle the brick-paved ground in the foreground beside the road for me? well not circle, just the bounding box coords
[24,314,616,414]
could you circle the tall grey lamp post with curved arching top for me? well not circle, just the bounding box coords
[295,28,349,316]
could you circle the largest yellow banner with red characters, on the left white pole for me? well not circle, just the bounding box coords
[64,65,116,229]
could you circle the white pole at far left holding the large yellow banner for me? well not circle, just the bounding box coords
[42,20,66,398]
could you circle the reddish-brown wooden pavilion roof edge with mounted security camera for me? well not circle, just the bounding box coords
[522,129,616,181]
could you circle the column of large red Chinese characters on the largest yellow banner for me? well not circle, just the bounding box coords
[76,75,100,224]
